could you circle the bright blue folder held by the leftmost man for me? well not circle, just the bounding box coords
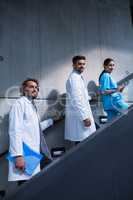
[7,143,43,176]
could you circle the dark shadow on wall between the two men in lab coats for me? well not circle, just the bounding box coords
[39,89,66,150]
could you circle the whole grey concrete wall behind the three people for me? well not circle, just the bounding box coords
[0,0,133,194]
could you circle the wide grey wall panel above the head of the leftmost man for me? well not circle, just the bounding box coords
[0,0,40,96]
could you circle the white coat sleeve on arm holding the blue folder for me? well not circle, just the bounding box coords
[9,102,24,156]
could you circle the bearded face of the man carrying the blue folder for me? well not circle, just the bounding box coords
[24,81,39,99]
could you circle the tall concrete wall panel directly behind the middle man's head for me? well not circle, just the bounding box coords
[40,0,99,96]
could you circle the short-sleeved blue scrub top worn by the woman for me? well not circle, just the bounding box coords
[99,72,117,110]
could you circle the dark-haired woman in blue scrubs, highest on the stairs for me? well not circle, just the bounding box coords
[99,58,125,121]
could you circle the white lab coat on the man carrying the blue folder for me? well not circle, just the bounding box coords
[8,96,53,181]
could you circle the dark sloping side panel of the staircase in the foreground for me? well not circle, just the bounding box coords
[6,107,133,200]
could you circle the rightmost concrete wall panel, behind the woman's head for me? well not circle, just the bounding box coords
[98,0,133,80]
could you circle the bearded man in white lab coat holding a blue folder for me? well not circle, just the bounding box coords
[8,79,53,183]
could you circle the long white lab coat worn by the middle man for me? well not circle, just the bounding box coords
[65,70,96,141]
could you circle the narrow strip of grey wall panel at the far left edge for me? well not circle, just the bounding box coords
[0,0,11,96]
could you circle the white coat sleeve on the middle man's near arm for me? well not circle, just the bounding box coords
[68,76,89,121]
